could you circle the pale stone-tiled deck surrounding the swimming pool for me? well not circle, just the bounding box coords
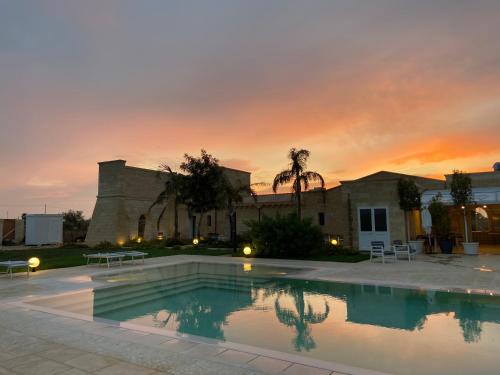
[0,255,500,375]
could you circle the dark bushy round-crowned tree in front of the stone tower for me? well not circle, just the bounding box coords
[181,150,226,235]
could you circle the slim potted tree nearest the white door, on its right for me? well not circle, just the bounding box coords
[398,178,424,254]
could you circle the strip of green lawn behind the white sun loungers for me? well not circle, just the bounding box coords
[0,246,231,270]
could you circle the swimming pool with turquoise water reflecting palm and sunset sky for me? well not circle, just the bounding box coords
[26,263,500,375]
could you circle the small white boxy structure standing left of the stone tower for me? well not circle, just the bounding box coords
[26,214,63,246]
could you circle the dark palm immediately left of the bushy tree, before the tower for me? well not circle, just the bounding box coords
[149,164,185,240]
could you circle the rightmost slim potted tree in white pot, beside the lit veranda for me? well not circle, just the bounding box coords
[450,170,479,255]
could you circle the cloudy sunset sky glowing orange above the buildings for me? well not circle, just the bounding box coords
[0,0,500,218]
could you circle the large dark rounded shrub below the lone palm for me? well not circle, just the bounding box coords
[247,214,324,257]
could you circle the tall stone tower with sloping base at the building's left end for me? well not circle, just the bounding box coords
[85,160,250,245]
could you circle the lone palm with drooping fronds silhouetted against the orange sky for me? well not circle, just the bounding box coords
[273,148,325,219]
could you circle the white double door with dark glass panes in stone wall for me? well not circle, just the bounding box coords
[358,207,390,250]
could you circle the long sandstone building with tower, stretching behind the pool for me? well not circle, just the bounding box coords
[86,160,500,250]
